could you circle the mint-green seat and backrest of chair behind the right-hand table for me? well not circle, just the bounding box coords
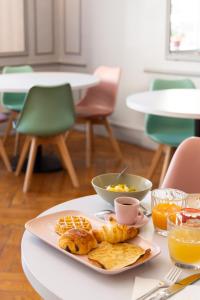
[145,79,195,134]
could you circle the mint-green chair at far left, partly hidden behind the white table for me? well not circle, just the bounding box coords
[2,65,33,155]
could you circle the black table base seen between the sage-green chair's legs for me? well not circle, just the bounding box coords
[12,146,62,173]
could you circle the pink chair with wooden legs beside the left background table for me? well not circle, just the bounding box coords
[76,66,122,167]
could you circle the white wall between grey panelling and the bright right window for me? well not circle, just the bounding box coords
[57,0,200,146]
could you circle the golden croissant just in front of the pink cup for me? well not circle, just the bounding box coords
[93,223,138,244]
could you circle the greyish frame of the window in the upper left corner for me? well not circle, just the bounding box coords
[0,0,28,57]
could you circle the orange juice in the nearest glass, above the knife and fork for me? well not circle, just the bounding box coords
[168,227,200,264]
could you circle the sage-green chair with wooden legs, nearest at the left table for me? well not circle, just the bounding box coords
[16,84,79,192]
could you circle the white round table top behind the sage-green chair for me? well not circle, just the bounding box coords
[0,72,99,93]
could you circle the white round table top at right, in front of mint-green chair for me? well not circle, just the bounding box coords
[126,89,200,119]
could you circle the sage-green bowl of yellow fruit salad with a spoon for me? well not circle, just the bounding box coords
[91,173,152,205]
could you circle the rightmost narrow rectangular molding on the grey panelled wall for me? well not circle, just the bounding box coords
[63,0,82,56]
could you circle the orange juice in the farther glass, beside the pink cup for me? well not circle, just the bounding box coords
[152,203,182,230]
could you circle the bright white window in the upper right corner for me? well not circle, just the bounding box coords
[168,0,200,60]
